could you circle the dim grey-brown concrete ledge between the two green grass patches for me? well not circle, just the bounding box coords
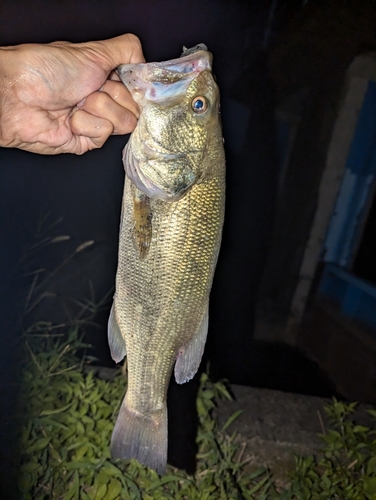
[216,385,372,478]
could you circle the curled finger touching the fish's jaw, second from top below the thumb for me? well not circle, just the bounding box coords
[79,92,137,135]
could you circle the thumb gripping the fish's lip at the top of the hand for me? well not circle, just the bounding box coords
[85,33,145,72]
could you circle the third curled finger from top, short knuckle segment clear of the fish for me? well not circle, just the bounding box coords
[70,109,114,149]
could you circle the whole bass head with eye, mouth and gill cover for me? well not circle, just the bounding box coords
[118,50,221,201]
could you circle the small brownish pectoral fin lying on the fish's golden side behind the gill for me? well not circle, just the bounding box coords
[132,186,152,260]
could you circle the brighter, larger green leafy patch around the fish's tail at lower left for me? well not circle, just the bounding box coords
[19,331,272,500]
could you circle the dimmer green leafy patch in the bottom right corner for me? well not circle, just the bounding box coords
[283,399,376,500]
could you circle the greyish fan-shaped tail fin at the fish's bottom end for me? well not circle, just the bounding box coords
[111,400,167,475]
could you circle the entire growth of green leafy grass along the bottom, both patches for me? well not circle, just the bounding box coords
[19,330,376,500]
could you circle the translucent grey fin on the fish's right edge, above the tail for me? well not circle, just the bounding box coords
[175,306,209,384]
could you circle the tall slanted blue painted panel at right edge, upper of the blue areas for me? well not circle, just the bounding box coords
[324,81,376,269]
